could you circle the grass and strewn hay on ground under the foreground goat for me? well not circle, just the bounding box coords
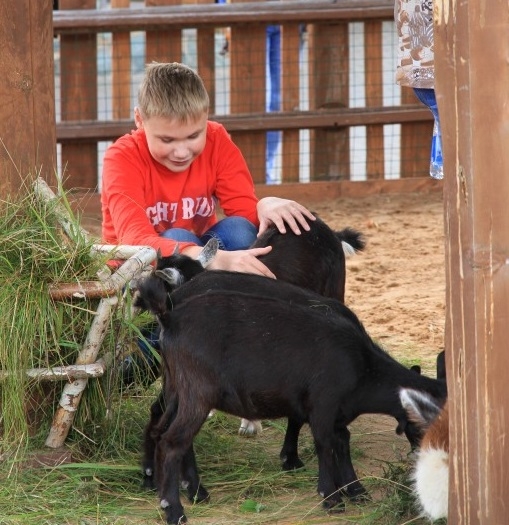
[0,406,432,525]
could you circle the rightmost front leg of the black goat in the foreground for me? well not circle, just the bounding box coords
[334,426,367,500]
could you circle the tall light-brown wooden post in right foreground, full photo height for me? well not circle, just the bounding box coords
[435,0,509,525]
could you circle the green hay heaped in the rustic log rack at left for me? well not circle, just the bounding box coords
[0,179,136,453]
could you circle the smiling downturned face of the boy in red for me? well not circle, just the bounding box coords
[134,108,208,173]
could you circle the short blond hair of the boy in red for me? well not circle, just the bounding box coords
[138,62,209,122]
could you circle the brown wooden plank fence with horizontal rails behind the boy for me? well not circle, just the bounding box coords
[53,0,432,189]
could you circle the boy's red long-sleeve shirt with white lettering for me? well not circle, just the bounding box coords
[101,121,259,256]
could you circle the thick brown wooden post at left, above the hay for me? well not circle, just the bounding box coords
[0,0,56,196]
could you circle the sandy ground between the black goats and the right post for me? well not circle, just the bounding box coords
[312,188,445,374]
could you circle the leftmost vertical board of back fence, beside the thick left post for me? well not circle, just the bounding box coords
[59,0,98,189]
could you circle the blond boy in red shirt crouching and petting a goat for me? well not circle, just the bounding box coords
[101,62,314,277]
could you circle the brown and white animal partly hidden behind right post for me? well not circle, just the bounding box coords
[400,388,449,520]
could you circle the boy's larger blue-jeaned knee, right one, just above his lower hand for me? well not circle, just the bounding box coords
[200,217,258,252]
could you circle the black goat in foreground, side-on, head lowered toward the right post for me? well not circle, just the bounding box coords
[137,272,446,524]
